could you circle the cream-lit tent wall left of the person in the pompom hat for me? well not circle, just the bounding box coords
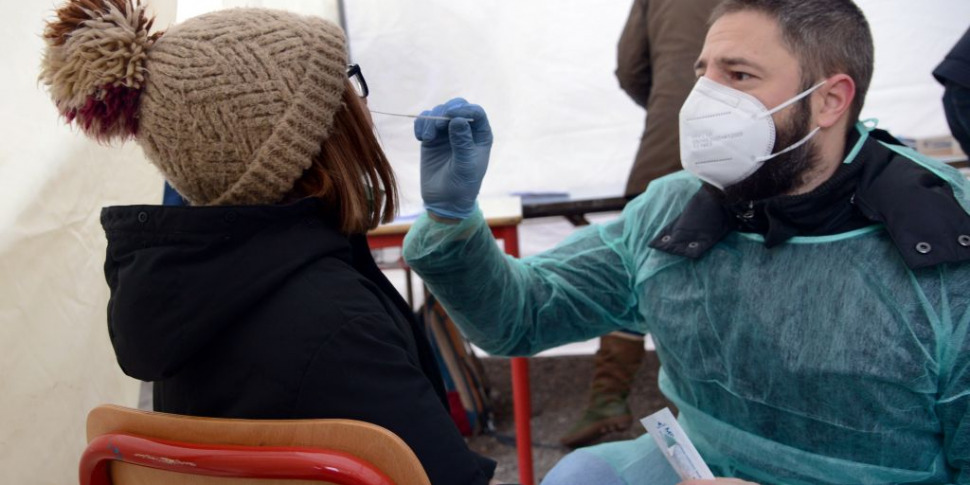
[0,4,175,484]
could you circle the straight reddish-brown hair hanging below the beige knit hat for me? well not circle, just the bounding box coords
[287,81,398,234]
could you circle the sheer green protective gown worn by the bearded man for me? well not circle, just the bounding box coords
[405,133,970,484]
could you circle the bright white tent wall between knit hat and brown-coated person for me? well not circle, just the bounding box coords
[346,0,643,211]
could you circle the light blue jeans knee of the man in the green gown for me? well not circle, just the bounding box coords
[542,434,681,485]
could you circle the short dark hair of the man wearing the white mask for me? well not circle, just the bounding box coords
[711,0,873,126]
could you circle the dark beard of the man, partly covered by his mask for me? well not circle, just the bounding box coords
[721,98,819,205]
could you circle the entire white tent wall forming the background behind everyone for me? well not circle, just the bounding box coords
[0,0,970,484]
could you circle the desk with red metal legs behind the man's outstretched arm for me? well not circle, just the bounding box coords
[367,197,535,485]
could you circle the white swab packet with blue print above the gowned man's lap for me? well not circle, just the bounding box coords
[640,408,714,480]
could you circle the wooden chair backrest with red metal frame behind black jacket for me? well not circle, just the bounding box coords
[81,404,430,485]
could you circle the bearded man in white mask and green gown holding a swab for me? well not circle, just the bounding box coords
[405,0,970,485]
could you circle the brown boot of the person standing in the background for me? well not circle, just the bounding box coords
[559,333,645,448]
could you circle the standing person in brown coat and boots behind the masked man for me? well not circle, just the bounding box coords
[559,0,720,448]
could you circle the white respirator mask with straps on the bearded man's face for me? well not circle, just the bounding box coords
[680,77,825,190]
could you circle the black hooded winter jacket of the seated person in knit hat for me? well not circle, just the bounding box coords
[101,199,495,485]
